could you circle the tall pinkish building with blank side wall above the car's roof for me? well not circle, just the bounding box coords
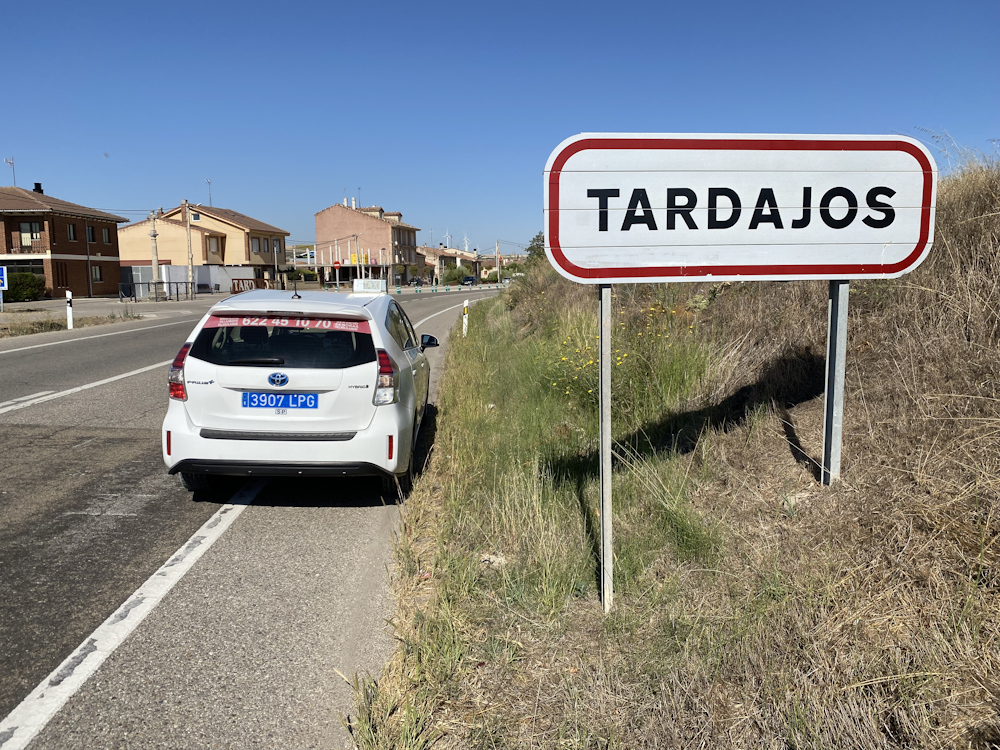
[315,198,420,281]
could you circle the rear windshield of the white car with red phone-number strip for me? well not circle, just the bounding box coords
[189,315,377,369]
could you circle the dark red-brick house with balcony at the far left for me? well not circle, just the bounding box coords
[0,182,128,297]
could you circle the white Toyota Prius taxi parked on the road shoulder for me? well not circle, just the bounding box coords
[162,289,438,494]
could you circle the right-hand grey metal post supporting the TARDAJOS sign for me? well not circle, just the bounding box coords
[822,280,851,485]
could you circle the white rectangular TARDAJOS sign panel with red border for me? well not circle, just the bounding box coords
[544,133,937,284]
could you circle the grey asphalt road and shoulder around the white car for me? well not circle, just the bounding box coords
[0,292,491,750]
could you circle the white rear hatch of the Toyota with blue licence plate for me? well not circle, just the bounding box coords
[184,315,378,438]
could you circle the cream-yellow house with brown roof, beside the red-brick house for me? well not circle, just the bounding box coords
[118,204,289,283]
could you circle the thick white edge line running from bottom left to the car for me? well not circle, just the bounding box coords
[0,479,267,750]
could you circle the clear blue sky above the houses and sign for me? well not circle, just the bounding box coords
[0,0,1000,253]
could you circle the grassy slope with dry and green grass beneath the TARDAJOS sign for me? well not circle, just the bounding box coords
[351,164,1000,749]
